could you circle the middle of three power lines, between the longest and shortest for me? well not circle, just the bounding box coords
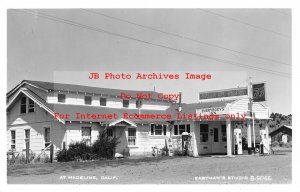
[82,9,291,67]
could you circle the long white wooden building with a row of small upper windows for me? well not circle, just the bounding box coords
[7,80,269,156]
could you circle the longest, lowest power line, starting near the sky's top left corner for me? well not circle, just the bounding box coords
[14,9,291,78]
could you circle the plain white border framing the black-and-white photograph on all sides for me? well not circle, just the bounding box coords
[0,0,300,192]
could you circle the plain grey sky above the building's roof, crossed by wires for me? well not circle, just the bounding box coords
[7,9,292,114]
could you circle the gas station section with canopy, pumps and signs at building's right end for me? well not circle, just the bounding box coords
[175,81,270,156]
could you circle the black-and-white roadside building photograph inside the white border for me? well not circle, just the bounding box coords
[2,0,297,188]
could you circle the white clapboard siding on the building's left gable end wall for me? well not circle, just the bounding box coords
[7,94,65,154]
